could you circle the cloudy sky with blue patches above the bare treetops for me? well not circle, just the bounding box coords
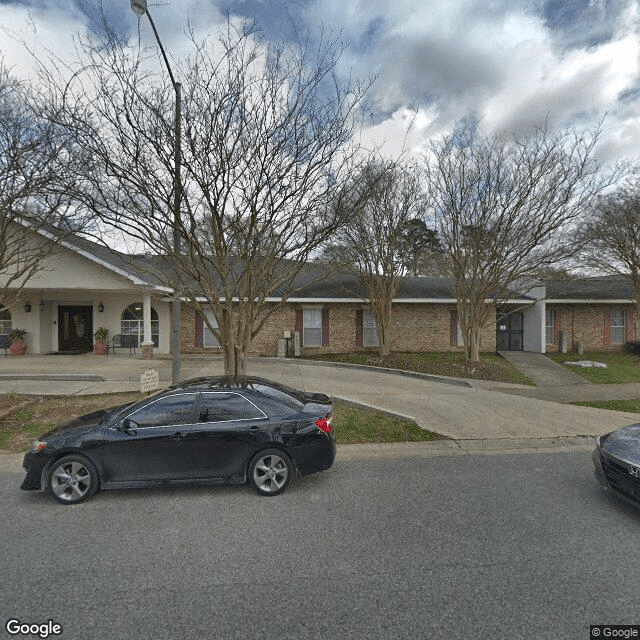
[0,0,640,160]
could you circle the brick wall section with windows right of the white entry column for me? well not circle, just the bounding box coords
[547,304,638,352]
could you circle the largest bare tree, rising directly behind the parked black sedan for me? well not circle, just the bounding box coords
[38,15,367,377]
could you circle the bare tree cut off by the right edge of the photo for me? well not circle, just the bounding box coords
[579,177,640,335]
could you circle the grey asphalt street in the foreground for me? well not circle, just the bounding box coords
[0,451,640,640]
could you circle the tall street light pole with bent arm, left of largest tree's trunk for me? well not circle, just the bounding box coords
[131,0,182,384]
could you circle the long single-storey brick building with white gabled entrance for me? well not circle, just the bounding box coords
[0,225,640,356]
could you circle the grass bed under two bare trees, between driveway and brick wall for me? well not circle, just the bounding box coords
[305,350,533,384]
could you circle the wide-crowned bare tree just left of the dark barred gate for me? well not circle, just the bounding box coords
[425,118,622,362]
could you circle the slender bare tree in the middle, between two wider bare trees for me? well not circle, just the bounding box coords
[326,159,424,355]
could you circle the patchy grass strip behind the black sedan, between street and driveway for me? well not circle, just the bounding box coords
[0,393,443,453]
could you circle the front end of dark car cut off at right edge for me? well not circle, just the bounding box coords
[593,423,640,508]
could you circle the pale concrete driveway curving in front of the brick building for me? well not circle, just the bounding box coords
[0,354,640,448]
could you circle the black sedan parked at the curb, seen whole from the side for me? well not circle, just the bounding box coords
[21,378,336,504]
